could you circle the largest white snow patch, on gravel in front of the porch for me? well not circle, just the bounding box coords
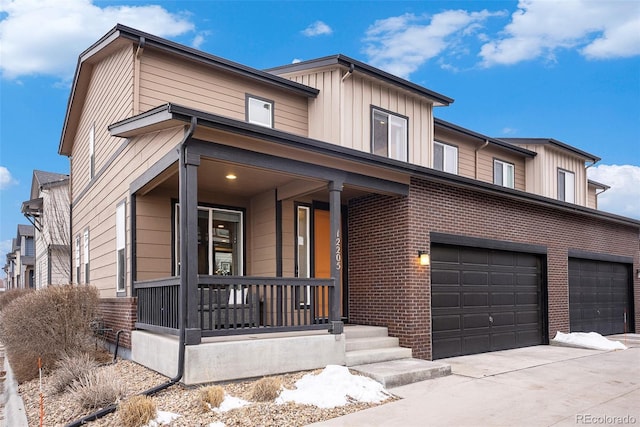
[276,365,390,408]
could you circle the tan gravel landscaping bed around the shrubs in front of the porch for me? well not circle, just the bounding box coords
[19,360,396,427]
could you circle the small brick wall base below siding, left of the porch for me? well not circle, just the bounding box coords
[99,298,137,348]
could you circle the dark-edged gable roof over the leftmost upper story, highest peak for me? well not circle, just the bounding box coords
[58,24,319,156]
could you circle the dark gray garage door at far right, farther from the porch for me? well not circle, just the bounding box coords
[569,258,633,335]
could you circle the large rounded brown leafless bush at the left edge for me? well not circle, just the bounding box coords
[0,285,98,382]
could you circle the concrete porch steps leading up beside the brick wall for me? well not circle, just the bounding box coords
[344,325,451,388]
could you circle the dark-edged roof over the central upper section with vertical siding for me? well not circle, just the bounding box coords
[265,54,453,106]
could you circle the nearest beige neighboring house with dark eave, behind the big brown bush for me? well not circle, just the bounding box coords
[22,170,71,289]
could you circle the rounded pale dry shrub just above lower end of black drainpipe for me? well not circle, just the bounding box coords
[69,366,125,409]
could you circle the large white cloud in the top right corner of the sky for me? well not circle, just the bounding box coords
[480,0,640,66]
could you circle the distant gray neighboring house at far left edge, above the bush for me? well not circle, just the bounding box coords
[4,224,36,290]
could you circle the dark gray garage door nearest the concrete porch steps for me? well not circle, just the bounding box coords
[431,244,544,359]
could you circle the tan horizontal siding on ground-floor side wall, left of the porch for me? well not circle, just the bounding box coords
[72,126,185,297]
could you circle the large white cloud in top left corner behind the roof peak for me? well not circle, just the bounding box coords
[0,0,195,79]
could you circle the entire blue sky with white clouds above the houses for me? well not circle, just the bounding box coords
[0,0,640,278]
